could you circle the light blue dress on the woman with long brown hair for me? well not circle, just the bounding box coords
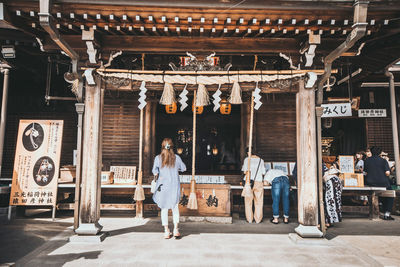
[153,155,186,209]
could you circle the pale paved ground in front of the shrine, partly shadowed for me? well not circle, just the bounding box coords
[0,215,400,266]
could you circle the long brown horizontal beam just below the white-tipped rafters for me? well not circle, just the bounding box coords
[43,35,341,54]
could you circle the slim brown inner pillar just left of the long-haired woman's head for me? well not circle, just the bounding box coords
[143,102,153,181]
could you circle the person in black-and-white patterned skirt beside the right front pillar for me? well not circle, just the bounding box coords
[324,167,343,227]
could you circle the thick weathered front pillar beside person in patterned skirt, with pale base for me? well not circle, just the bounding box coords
[295,80,322,237]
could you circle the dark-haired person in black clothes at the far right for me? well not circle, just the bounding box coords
[364,147,394,220]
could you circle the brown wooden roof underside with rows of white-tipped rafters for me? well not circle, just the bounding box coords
[0,0,400,84]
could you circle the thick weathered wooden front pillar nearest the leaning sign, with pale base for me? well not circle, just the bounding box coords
[75,77,102,235]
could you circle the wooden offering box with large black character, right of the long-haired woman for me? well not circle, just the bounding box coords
[179,184,231,217]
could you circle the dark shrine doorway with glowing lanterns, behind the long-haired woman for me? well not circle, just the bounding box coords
[156,100,241,174]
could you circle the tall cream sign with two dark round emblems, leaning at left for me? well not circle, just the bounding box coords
[10,120,64,206]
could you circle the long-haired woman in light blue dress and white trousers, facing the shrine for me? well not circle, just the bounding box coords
[153,138,186,239]
